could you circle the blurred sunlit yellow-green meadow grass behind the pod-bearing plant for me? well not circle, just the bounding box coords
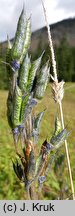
[0,83,75,200]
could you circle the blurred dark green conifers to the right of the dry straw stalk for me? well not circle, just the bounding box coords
[56,37,75,82]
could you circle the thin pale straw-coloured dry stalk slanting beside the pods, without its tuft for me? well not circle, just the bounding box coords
[41,0,75,200]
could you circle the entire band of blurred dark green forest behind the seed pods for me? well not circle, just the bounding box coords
[0,37,75,89]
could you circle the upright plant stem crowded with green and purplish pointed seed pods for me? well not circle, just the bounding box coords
[6,8,69,199]
